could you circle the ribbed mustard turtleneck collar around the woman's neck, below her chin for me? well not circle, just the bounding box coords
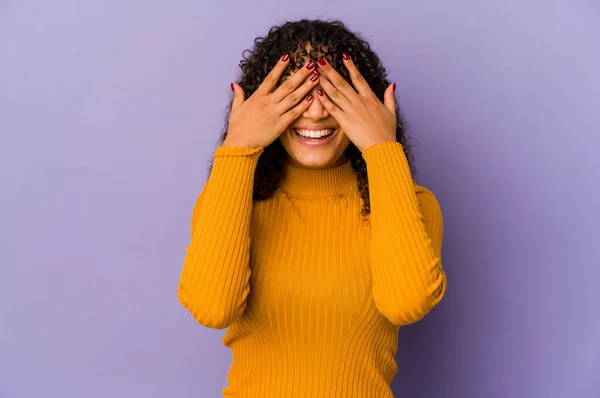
[279,159,358,198]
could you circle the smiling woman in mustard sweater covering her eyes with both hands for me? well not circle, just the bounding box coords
[179,20,446,398]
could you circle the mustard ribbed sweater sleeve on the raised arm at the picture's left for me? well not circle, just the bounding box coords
[178,146,263,329]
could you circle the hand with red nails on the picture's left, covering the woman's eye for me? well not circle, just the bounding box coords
[223,58,320,148]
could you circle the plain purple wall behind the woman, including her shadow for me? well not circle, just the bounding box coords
[0,0,600,398]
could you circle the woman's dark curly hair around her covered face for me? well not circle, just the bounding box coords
[209,19,416,216]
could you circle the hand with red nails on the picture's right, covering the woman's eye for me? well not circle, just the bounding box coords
[318,58,397,152]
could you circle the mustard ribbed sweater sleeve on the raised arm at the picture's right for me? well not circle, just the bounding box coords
[362,142,447,325]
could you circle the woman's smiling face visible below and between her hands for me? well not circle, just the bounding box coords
[278,44,351,168]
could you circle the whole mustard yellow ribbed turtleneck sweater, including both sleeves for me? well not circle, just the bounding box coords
[178,142,446,398]
